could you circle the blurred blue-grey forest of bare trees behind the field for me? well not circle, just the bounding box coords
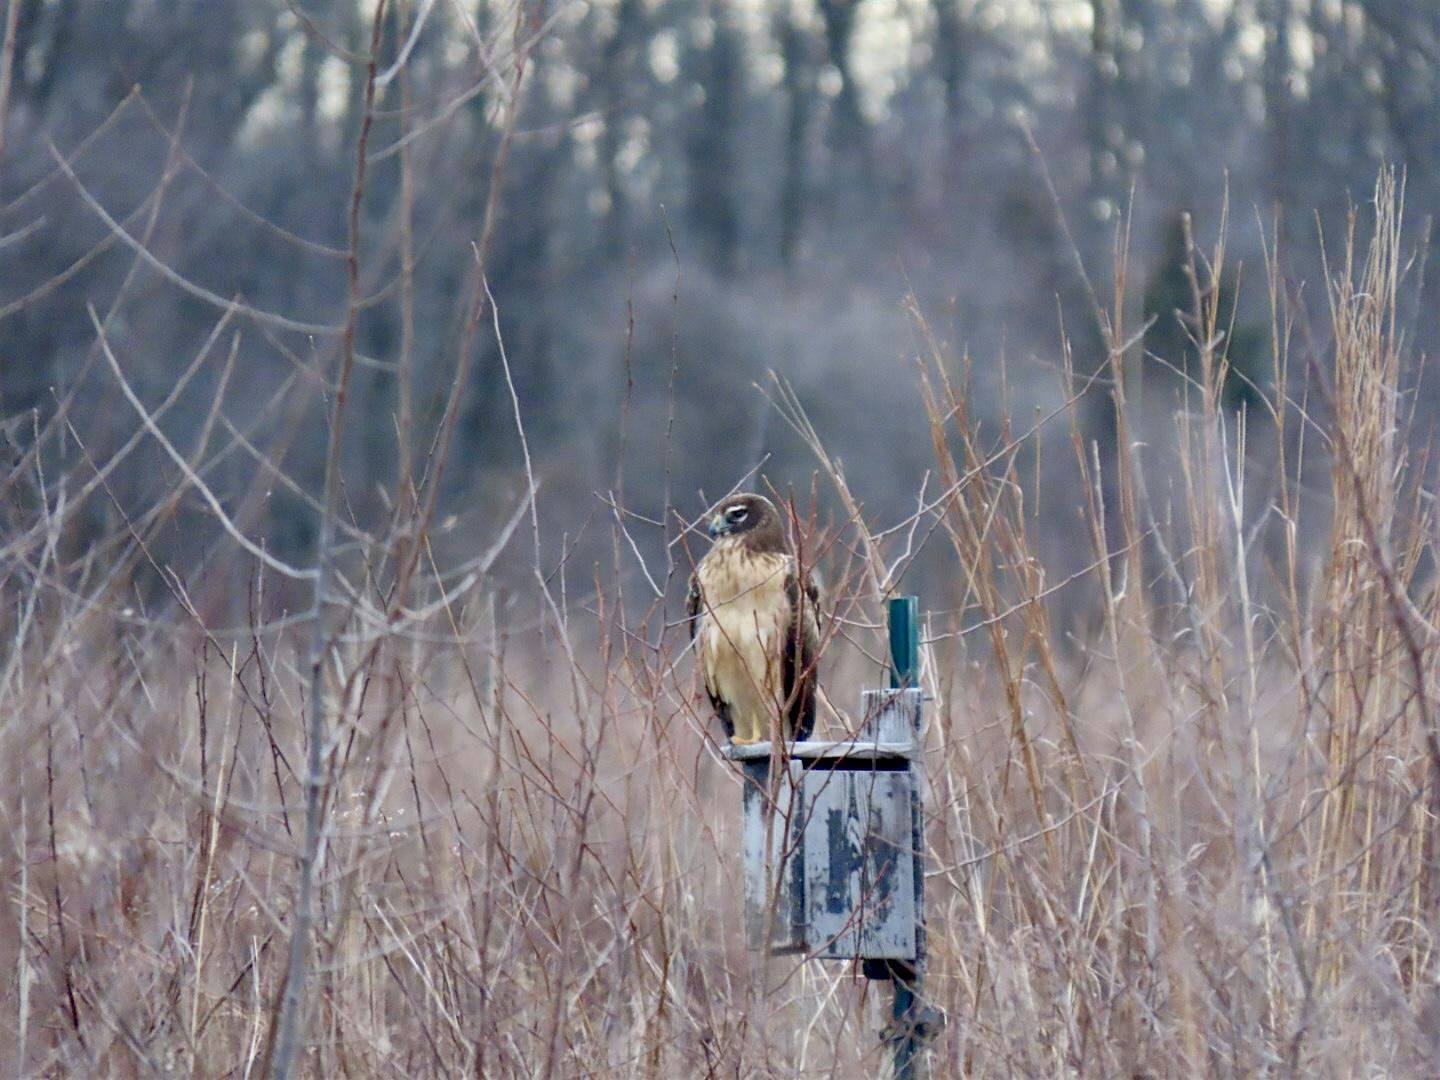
[0,0,1440,587]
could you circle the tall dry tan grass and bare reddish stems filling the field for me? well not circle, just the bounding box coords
[0,50,1440,1077]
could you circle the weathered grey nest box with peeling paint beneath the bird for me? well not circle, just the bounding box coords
[730,690,924,960]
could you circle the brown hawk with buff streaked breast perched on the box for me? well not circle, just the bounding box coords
[688,494,819,746]
